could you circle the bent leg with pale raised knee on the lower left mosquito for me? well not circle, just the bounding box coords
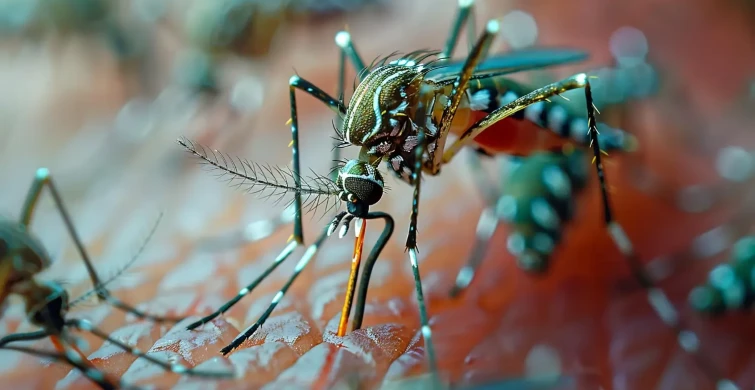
[20,168,181,322]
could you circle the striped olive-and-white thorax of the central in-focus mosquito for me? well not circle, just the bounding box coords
[343,61,424,151]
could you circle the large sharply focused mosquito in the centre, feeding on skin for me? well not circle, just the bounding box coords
[179,1,620,378]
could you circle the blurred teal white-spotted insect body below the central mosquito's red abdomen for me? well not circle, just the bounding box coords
[451,149,589,296]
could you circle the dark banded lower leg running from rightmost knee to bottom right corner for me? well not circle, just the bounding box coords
[585,81,737,389]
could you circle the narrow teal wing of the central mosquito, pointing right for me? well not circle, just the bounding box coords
[425,48,588,84]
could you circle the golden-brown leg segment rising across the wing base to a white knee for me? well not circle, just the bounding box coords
[431,20,500,174]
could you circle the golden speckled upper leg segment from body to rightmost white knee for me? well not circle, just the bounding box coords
[438,73,587,164]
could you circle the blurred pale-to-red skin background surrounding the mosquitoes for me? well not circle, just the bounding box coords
[0,0,755,389]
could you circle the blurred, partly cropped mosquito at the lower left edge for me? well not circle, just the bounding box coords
[0,168,235,389]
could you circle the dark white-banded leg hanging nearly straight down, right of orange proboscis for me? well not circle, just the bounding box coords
[406,127,438,374]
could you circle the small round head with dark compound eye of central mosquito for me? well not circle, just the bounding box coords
[337,160,384,206]
